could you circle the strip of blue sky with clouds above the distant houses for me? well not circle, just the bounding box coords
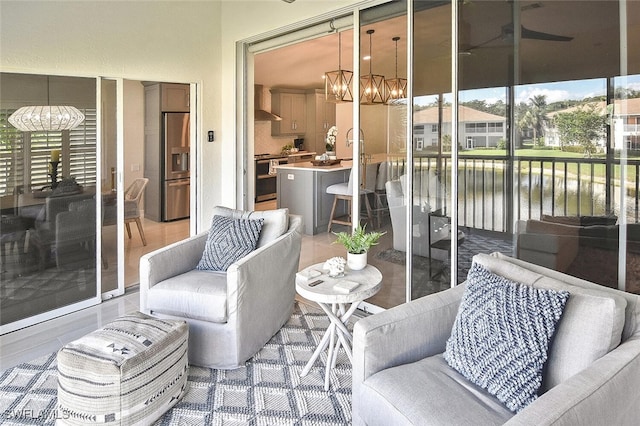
[416,75,640,105]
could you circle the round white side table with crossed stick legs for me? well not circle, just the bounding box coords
[296,262,382,390]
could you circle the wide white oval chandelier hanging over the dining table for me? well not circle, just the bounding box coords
[9,77,84,132]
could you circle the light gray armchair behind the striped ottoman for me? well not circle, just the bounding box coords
[140,207,302,369]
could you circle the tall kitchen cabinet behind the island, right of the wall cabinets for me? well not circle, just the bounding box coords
[304,89,336,154]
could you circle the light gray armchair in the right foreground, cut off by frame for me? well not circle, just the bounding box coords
[353,253,640,425]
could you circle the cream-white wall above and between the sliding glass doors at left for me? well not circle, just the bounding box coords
[0,0,356,228]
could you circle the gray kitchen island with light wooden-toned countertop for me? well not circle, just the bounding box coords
[276,160,352,235]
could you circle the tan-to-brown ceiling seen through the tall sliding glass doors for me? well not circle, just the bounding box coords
[254,0,640,94]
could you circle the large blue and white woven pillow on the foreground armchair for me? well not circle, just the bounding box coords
[444,263,569,412]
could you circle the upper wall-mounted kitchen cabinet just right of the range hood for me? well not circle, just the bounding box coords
[271,89,307,136]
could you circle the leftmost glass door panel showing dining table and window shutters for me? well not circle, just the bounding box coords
[0,73,96,325]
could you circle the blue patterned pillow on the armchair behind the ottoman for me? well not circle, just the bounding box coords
[196,215,264,271]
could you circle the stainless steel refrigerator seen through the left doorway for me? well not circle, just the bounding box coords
[162,112,190,222]
